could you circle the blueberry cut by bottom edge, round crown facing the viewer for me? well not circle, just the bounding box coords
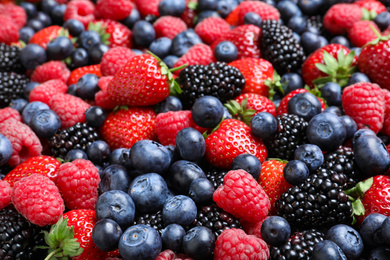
[119,224,162,260]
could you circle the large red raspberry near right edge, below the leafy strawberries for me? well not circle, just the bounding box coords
[341,82,385,133]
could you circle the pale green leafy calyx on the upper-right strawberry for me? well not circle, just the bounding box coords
[313,50,356,87]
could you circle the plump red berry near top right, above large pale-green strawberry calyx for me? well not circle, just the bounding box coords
[323,3,363,34]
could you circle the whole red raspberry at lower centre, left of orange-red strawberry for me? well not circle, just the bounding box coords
[213,170,271,222]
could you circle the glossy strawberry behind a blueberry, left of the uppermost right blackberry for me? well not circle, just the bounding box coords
[210,24,260,59]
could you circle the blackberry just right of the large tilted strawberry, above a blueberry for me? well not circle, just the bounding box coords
[178,62,245,109]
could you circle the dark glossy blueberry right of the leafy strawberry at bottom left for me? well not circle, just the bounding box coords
[92,218,123,252]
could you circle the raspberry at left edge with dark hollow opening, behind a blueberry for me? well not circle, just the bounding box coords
[0,119,42,167]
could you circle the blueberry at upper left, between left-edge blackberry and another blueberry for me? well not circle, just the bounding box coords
[19,44,46,70]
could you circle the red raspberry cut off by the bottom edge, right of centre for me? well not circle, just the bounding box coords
[214,228,270,260]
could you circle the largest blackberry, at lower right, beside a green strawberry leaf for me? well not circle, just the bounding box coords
[275,168,352,230]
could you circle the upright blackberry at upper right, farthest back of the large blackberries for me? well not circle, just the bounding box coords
[260,20,306,74]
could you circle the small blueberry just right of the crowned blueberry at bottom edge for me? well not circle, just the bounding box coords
[161,224,186,252]
